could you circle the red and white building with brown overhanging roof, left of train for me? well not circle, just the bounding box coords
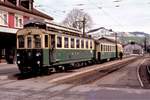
[0,0,53,62]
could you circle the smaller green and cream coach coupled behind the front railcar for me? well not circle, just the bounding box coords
[96,37,122,62]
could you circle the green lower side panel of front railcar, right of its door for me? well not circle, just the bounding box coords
[56,49,94,62]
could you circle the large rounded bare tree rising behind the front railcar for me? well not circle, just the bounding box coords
[63,9,93,30]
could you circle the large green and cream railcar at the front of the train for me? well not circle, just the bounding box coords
[17,22,95,73]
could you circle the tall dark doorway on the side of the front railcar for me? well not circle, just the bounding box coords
[50,34,56,63]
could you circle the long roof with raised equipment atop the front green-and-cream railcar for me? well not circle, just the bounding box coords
[24,20,91,38]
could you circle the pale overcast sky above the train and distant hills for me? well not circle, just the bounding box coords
[34,0,150,33]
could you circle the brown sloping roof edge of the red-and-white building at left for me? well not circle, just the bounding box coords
[0,0,53,20]
